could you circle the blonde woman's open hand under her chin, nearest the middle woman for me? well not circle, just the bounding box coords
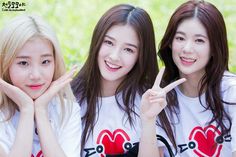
[34,66,77,110]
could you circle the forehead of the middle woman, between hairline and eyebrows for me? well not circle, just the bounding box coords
[106,24,139,46]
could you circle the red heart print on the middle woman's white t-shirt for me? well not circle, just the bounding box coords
[96,129,131,157]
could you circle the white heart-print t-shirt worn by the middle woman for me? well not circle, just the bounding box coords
[81,96,141,157]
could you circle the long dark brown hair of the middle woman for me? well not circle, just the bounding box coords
[72,4,158,149]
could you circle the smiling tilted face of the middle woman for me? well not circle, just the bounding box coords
[98,25,139,92]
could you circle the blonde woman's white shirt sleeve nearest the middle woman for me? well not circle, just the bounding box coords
[58,103,82,157]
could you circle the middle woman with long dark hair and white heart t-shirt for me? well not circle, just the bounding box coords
[72,4,175,157]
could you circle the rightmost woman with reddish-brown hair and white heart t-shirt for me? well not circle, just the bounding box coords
[146,0,236,157]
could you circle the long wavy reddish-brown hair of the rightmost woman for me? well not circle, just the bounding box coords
[158,0,231,150]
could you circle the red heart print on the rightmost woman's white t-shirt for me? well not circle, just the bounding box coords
[189,125,222,157]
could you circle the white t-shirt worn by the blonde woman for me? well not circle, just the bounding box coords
[0,99,82,157]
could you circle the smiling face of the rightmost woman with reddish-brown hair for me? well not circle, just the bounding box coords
[171,18,210,77]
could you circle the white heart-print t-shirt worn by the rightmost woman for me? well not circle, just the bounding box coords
[157,72,236,157]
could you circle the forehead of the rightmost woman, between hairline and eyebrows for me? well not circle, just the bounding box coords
[177,18,207,36]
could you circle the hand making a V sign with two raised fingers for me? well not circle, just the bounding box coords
[141,68,186,120]
